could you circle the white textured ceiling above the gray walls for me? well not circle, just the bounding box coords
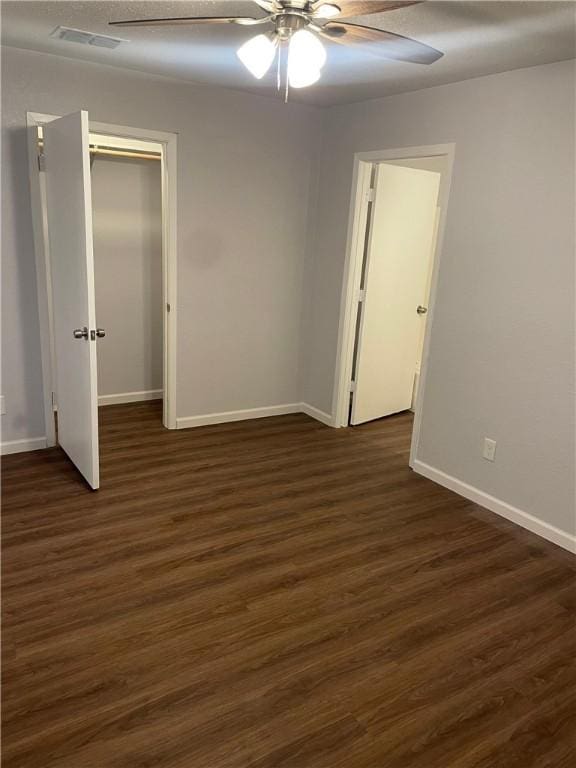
[2,0,576,106]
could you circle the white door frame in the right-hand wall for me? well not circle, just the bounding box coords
[332,144,456,466]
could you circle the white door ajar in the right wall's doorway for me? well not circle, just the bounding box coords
[351,163,440,424]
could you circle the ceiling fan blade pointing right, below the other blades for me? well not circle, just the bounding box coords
[321,21,444,64]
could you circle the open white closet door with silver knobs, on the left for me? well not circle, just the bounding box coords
[44,112,99,489]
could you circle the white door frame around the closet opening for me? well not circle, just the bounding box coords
[26,112,178,440]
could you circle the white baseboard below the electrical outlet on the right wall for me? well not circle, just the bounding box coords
[412,460,576,553]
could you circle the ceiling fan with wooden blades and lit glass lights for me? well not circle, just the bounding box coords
[110,0,443,98]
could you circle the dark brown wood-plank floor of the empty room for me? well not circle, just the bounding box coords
[2,403,576,768]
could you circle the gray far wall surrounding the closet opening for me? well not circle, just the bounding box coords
[2,48,321,441]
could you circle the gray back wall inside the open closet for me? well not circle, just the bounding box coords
[92,156,162,395]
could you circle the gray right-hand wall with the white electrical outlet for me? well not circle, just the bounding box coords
[302,62,575,532]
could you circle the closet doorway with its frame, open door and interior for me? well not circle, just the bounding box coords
[27,111,176,489]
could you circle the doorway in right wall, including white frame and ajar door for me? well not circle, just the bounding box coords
[334,145,454,462]
